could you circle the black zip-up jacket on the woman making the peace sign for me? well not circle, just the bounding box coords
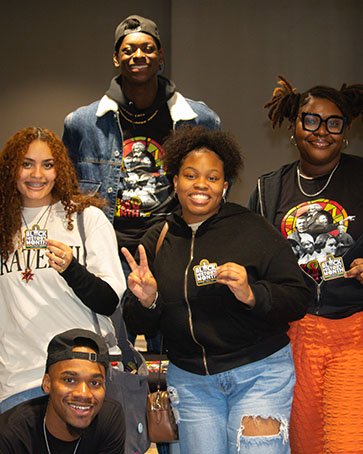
[124,203,311,375]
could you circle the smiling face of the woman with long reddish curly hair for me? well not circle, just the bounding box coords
[17,140,57,207]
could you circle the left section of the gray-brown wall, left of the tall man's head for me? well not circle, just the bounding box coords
[0,0,170,142]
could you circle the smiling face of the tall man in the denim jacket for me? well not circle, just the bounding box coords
[113,32,163,84]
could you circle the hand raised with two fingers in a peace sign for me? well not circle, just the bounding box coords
[121,244,158,307]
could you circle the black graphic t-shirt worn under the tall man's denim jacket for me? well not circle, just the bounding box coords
[114,103,177,254]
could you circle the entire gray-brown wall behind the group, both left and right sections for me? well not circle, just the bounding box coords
[0,0,363,204]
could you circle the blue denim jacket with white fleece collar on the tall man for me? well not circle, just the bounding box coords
[63,92,220,222]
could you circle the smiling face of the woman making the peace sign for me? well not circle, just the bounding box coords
[174,148,228,224]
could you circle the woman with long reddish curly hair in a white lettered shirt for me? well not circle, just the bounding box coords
[0,127,125,413]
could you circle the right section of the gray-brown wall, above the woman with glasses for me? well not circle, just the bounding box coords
[171,0,363,204]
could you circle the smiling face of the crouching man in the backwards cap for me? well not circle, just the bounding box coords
[43,347,106,441]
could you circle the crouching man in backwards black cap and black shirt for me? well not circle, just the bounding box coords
[0,329,125,454]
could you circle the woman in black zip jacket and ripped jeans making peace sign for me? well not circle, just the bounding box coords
[122,127,310,454]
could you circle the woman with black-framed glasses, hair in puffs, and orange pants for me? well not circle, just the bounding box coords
[249,76,363,454]
